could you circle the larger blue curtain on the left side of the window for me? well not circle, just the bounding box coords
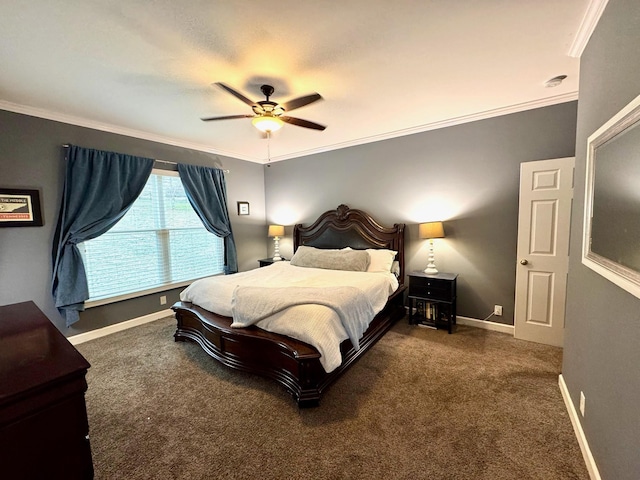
[51,145,154,326]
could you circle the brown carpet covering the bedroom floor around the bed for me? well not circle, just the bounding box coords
[78,318,589,480]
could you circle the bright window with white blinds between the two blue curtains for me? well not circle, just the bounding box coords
[79,170,224,306]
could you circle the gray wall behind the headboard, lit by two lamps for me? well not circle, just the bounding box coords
[265,102,577,324]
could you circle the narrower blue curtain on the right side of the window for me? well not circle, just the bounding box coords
[178,164,238,274]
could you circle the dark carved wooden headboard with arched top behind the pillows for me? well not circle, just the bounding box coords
[293,205,405,285]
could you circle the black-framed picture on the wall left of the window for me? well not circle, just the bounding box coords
[0,188,42,227]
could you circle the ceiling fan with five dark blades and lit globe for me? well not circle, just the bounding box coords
[201,82,327,134]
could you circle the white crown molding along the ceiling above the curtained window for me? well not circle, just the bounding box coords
[0,100,263,163]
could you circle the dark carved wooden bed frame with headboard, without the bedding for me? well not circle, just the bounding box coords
[172,205,406,407]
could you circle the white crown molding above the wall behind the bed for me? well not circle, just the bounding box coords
[271,92,578,163]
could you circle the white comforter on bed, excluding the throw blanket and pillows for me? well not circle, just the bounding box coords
[180,262,398,372]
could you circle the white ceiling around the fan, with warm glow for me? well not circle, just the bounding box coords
[0,0,593,163]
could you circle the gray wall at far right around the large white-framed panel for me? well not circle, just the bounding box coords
[562,0,640,480]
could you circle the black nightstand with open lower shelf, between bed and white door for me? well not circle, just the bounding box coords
[408,272,458,333]
